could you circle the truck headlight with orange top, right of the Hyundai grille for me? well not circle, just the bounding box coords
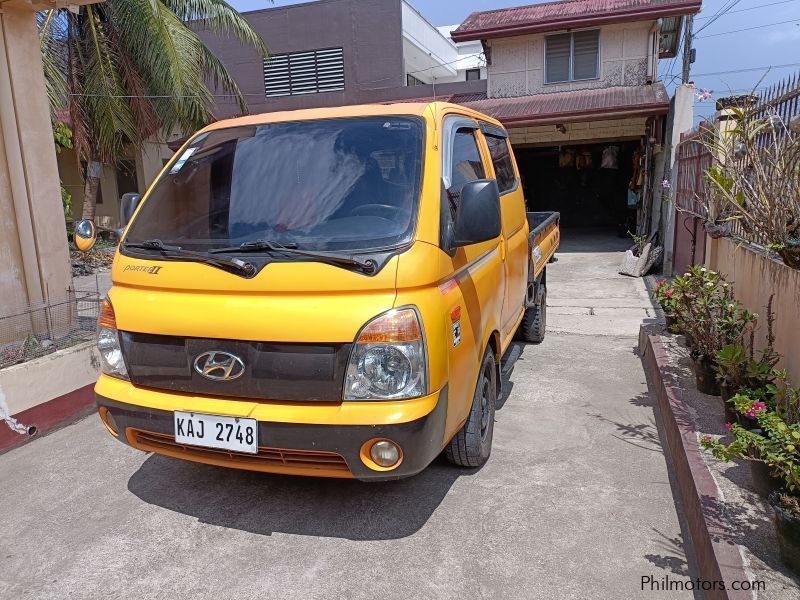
[344,308,428,400]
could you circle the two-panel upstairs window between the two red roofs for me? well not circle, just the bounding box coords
[544,29,600,83]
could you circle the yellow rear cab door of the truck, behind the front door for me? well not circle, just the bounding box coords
[481,122,529,349]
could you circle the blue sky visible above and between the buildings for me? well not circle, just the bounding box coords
[228,0,800,119]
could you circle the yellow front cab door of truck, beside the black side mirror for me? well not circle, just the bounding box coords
[439,115,505,433]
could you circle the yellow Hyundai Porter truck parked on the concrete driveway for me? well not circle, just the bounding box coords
[76,102,559,480]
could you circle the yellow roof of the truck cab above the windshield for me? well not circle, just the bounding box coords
[203,101,502,131]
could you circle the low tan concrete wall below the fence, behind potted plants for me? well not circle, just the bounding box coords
[706,238,800,385]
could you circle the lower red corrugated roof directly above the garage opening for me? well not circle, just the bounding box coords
[400,81,669,127]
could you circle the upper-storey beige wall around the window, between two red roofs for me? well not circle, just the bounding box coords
[488,21,653,98]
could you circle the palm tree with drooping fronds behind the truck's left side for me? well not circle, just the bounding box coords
[39,0,267,219]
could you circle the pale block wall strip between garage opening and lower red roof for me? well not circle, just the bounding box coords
[508,117,647,146]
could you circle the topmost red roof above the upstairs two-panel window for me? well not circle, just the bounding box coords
[450,0,701,42]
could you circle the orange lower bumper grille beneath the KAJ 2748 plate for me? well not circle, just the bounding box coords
[127,429,352,477]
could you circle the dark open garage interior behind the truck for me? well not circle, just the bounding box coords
[514,140,643,236]
